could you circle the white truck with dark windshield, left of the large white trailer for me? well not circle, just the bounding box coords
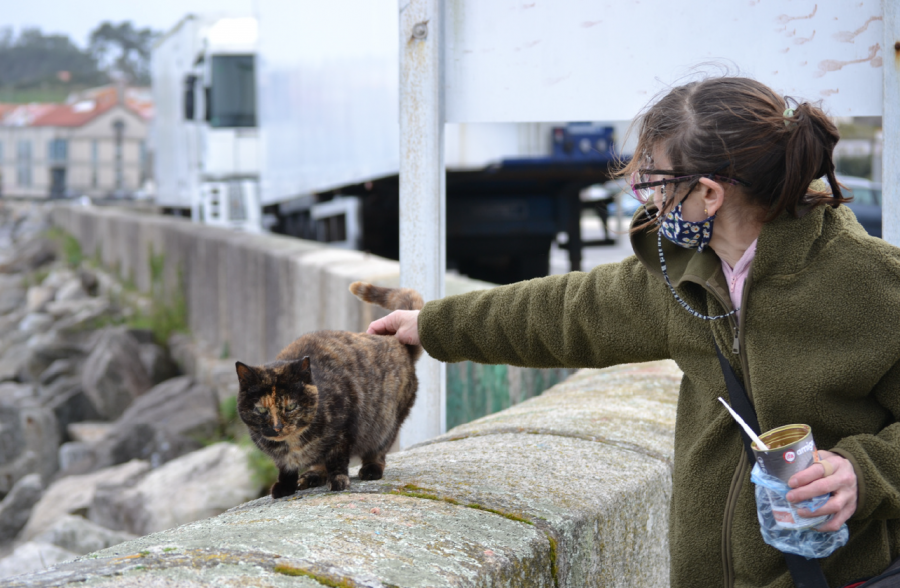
[151,15,260,231]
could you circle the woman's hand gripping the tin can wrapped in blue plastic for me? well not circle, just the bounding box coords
[787,451,857,531]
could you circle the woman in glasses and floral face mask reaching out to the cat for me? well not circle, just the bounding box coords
[369,78,900,588]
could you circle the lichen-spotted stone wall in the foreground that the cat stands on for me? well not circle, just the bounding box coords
[5,362,681,588]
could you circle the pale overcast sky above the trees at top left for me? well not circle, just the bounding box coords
[0,0,262,47]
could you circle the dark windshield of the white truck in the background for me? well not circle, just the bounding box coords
[207,55,256,128]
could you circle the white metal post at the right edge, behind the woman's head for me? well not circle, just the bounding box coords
[881,0,900,247]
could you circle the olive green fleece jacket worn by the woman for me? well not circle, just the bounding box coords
[419,207,900,588]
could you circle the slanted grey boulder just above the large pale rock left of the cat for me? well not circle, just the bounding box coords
[97,376,220,467]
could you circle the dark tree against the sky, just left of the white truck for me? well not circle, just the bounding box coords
[88,21,159,84]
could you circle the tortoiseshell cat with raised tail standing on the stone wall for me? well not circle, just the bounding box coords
[236,282,422,498]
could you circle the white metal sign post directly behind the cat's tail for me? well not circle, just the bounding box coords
[399,0,447,448]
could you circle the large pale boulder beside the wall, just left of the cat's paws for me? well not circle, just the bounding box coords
[89,443,259,535]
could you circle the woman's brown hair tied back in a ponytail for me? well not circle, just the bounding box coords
[617,77,849,221]
